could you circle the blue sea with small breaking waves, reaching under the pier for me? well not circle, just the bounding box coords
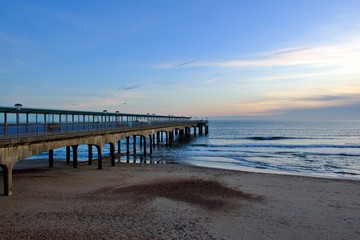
[26,119,360,180]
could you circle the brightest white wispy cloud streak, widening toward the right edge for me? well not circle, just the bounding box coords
[155,38,360,71]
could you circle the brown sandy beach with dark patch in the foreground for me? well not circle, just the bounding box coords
[0,162,360,239]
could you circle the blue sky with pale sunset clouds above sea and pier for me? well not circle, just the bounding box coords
[0,0,360,119]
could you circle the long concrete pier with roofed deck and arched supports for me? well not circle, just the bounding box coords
[0,104,209,196]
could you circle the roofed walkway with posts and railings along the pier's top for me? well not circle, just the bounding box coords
[0,104,201,147]
